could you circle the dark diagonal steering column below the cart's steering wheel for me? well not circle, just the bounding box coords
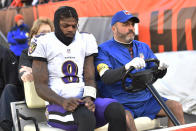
[146,84,180,126]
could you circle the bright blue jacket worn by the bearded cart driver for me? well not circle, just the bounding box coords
[95,39,156,107]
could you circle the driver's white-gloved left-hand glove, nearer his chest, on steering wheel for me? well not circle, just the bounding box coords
[125,57,146,70]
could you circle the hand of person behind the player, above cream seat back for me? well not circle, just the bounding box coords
[19,66,33,82]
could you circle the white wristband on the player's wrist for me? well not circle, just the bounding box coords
[83,86,97,99]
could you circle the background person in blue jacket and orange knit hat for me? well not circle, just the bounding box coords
[7,14,29,60]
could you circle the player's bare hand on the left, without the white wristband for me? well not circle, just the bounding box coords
[62,97,83,112]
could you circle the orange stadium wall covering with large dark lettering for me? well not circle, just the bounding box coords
[0,0,196,52]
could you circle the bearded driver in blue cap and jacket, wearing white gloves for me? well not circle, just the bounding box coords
[95,10,184,130]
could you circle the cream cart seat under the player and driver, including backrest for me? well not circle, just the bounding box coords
[24,82,160,131]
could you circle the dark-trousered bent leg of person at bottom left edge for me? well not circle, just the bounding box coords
[0,84,24,131]
